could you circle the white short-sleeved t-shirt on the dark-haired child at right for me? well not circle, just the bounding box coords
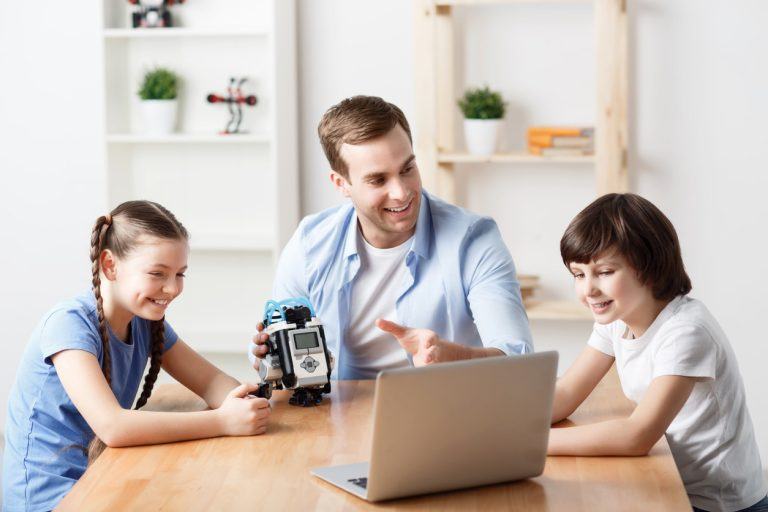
[589,296,768,511]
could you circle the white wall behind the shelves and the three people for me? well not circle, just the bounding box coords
[0,0,768,470]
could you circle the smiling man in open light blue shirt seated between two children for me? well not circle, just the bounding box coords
[249,96,533,379]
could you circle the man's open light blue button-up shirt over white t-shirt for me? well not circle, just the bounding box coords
[272,191,533,379]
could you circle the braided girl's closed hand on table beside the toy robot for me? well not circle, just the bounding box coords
[216,383,270,436]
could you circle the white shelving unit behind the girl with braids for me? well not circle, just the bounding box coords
[102,0,299,353]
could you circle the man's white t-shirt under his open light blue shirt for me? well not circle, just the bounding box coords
[344,229,413,379]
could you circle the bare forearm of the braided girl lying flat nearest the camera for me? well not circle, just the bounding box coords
[102,409,224,447]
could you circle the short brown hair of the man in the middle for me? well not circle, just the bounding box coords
[317,96,413,180]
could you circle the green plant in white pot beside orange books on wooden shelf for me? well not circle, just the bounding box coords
[458,85,506,155]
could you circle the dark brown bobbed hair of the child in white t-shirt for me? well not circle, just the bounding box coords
[560,194,691,300]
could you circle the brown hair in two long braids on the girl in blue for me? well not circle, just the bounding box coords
[91,201,189,409]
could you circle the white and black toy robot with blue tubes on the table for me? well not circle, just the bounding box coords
[257,298,334,407]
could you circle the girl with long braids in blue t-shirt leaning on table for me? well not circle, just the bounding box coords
[3,201,269,512]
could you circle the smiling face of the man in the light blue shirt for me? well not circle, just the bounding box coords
[331,125,421,248]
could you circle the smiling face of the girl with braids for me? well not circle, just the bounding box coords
[102,236,189,320]
